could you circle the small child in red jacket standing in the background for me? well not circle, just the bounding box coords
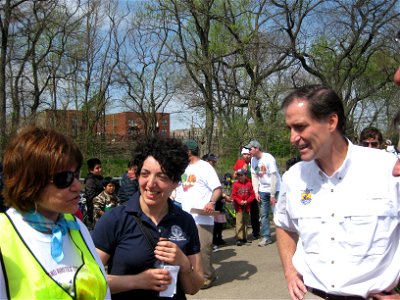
[232,169,255,246]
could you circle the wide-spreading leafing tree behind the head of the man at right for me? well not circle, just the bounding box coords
[271,0,400,137]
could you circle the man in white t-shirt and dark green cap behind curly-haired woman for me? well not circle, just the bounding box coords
[175,139,222,288]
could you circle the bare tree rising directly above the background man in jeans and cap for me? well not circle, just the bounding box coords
[220,0,293,125]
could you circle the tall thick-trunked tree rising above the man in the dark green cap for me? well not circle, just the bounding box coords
[158,0,219,152]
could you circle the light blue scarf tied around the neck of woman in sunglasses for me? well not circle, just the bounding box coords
[23,212,79,263]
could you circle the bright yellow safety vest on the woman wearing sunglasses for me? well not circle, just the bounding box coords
[0,213,107,300]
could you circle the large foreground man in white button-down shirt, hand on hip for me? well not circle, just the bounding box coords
[274,85,400,299]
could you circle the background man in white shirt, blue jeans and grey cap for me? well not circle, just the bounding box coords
[245,140,281,247]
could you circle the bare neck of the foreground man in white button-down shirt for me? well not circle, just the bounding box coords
[316,136,349,176]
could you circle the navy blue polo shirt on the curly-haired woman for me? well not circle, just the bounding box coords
[92,192,200,299]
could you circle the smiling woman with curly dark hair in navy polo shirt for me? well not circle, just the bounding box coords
[92,136,203,299]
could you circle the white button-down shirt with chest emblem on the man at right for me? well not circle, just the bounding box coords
[274,142,400,297]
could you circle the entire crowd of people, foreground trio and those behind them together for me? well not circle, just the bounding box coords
[0,68,400,300]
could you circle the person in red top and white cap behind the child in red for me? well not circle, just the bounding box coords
[233,148,260,239]
